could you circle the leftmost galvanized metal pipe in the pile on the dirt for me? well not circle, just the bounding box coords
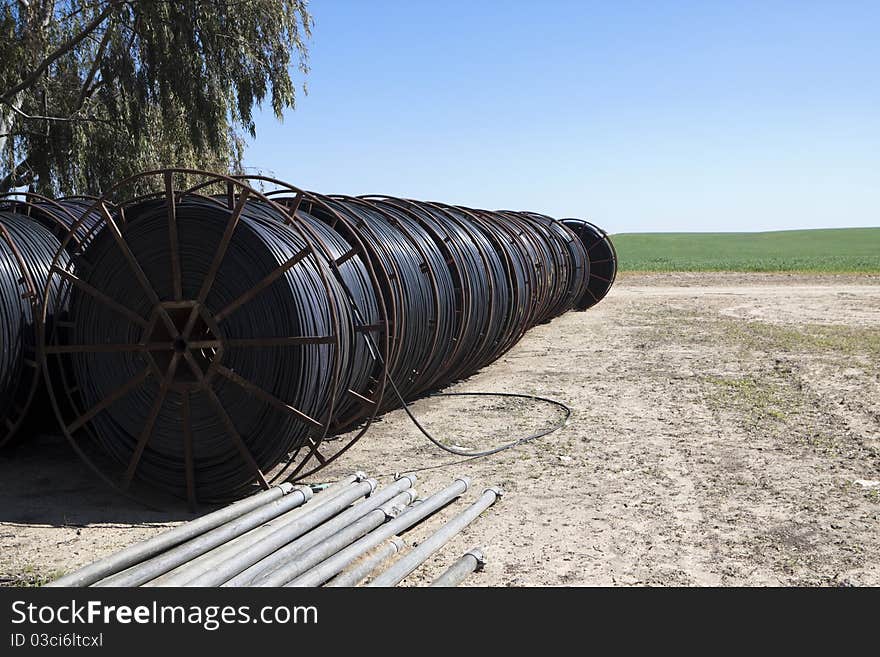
[46,484,294,586]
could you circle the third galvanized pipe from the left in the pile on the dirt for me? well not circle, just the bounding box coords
[144,472,367,587]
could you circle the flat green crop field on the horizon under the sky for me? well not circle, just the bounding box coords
[612,228,880,273]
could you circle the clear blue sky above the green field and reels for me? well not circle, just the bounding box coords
[246,0,880,232]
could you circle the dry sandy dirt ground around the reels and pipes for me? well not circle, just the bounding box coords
[0,274,880,586]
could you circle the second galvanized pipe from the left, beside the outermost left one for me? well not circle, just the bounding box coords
[93,486,312,586]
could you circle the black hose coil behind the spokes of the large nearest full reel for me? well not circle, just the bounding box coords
[61,196,353,501]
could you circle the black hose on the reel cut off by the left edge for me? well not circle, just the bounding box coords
[0,211,68,445]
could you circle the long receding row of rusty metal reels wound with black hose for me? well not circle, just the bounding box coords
[13,169,613,505]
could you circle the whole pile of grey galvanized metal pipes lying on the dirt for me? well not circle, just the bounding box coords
[48,473,499,587]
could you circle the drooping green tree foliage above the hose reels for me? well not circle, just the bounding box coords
[0,0,312,194]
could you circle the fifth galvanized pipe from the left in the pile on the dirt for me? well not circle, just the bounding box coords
[224,474,416,586]
